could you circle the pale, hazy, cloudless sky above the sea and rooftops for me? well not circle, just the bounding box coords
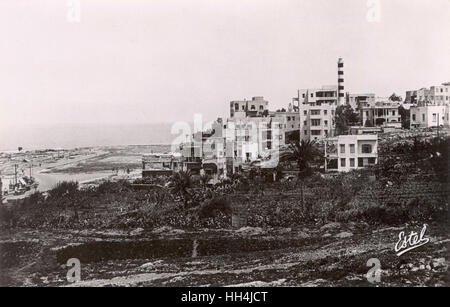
[0,0,450,131]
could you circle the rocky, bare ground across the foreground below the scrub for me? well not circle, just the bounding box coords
[0,223,450,287]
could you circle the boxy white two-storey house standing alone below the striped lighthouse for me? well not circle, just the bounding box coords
[325,134,378,172]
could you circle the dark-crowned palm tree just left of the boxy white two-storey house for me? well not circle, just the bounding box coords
[280,140,319,217]
